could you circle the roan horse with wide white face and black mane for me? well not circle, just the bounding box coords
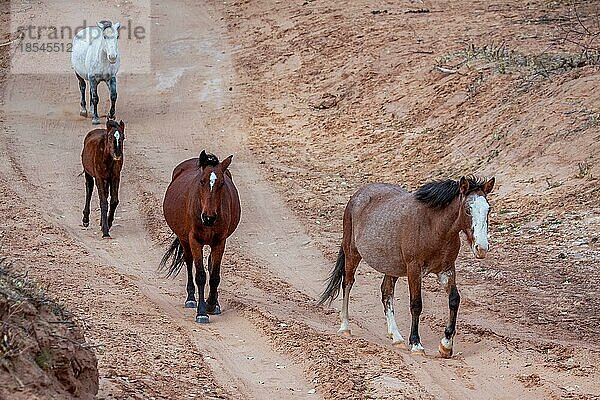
[319,177,494,358]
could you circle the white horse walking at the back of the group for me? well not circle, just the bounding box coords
[71,21,121,125]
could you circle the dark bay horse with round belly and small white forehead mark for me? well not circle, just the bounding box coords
[160,151,241,323]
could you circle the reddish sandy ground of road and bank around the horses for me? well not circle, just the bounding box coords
[0,1,600,399]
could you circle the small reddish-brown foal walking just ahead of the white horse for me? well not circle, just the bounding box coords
[81,119,125,237]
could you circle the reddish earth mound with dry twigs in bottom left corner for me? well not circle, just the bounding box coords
[0,258,98,398]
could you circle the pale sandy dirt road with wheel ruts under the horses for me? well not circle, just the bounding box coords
[0,1,600,399]
